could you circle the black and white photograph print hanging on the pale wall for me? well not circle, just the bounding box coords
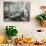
[4,1,30,21]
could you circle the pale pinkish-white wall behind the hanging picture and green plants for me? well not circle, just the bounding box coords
[0,0,46,40]
